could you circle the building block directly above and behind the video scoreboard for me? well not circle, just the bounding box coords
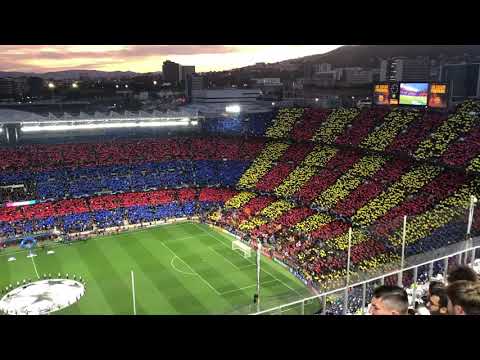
[380,58,430,82]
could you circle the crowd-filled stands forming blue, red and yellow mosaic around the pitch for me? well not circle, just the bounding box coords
[0,102,480,285]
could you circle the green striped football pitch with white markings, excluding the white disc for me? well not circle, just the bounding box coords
[0,222,319,315]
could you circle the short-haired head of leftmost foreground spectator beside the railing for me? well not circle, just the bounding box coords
[370,285,408,315]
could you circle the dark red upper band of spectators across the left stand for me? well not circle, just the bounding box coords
[0,137,264,173]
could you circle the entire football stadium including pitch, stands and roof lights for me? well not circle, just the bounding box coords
[0,97,480,315]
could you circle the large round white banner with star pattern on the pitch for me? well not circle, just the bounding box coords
[0,279,85,315]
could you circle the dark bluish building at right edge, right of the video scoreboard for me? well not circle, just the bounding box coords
[440,63,480,102]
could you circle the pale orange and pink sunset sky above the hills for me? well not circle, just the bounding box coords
[0,45,341,73]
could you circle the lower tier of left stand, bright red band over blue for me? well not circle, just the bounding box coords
[0,188,236,238]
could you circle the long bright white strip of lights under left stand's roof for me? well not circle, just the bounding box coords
[21,120,198,132]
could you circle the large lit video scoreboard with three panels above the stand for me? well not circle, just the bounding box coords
[373,82,448,109]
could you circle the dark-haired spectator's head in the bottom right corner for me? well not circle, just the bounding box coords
[447,280,480,315]
